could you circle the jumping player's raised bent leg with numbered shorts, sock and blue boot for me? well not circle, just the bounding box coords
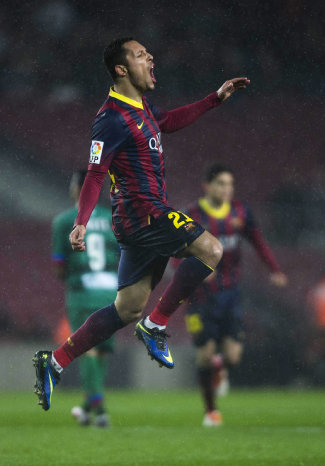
[135,211,222,368]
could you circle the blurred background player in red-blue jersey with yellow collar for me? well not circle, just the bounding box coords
[186,164,287,426]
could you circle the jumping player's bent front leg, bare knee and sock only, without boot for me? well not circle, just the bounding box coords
[149,231,222,326]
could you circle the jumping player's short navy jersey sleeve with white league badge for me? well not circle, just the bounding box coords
[88,109,128,173]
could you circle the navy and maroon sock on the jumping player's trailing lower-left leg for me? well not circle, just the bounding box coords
[53,303,126,368]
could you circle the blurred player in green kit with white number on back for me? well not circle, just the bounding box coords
[52,171,119,427]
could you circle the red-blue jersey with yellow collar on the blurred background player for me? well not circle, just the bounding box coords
[186,198,280,301]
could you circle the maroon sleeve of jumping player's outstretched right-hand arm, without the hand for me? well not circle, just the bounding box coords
[147,92,221,133]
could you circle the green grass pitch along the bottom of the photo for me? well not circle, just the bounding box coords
[0,388,325,466]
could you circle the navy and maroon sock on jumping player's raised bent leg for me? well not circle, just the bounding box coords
[149,256,213,325]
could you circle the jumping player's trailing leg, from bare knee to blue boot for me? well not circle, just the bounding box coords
[33,275,152,410]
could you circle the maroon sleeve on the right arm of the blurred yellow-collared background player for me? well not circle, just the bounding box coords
[244,206,281,272]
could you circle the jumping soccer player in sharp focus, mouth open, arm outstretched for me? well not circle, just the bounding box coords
[34,38,249,410]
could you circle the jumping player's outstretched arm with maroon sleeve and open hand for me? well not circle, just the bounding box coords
[151,78,250,133]
